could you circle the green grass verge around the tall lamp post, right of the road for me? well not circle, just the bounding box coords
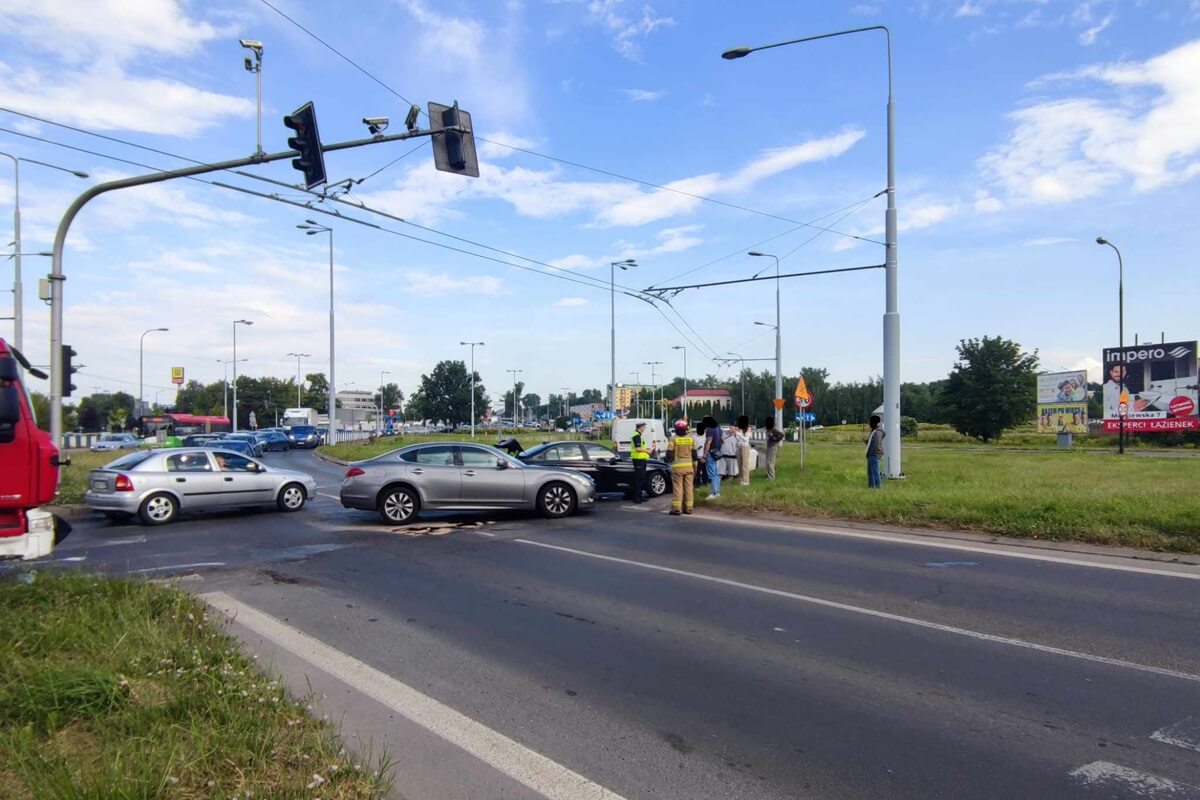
[718,441,1200,553]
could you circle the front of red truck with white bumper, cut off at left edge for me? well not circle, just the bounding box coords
[0,339,66,559]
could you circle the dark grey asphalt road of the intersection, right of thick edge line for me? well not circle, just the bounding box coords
[28,452,1200,800]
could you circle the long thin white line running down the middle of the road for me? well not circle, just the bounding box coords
[511,539,1200,682]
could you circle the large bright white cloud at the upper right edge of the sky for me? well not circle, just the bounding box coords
[979,40,1200,203]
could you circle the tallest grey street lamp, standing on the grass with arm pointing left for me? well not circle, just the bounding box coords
[721,25,904,479]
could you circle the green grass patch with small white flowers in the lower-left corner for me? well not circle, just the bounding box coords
[0,572,388,800]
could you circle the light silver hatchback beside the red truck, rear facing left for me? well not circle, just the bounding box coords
[84,447,317,525]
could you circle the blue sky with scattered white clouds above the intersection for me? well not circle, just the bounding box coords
[0,0,1200,410]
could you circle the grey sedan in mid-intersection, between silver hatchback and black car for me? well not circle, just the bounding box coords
[341,443,596,525]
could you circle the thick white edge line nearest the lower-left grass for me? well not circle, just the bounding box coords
[200,591,624,800]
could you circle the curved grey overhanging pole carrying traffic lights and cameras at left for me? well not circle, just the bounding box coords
[49,126,460,446]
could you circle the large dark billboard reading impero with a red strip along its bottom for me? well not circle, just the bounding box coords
[1103,341,1200,433]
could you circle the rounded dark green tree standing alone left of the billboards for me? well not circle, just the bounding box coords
[942,336,1038,441]
